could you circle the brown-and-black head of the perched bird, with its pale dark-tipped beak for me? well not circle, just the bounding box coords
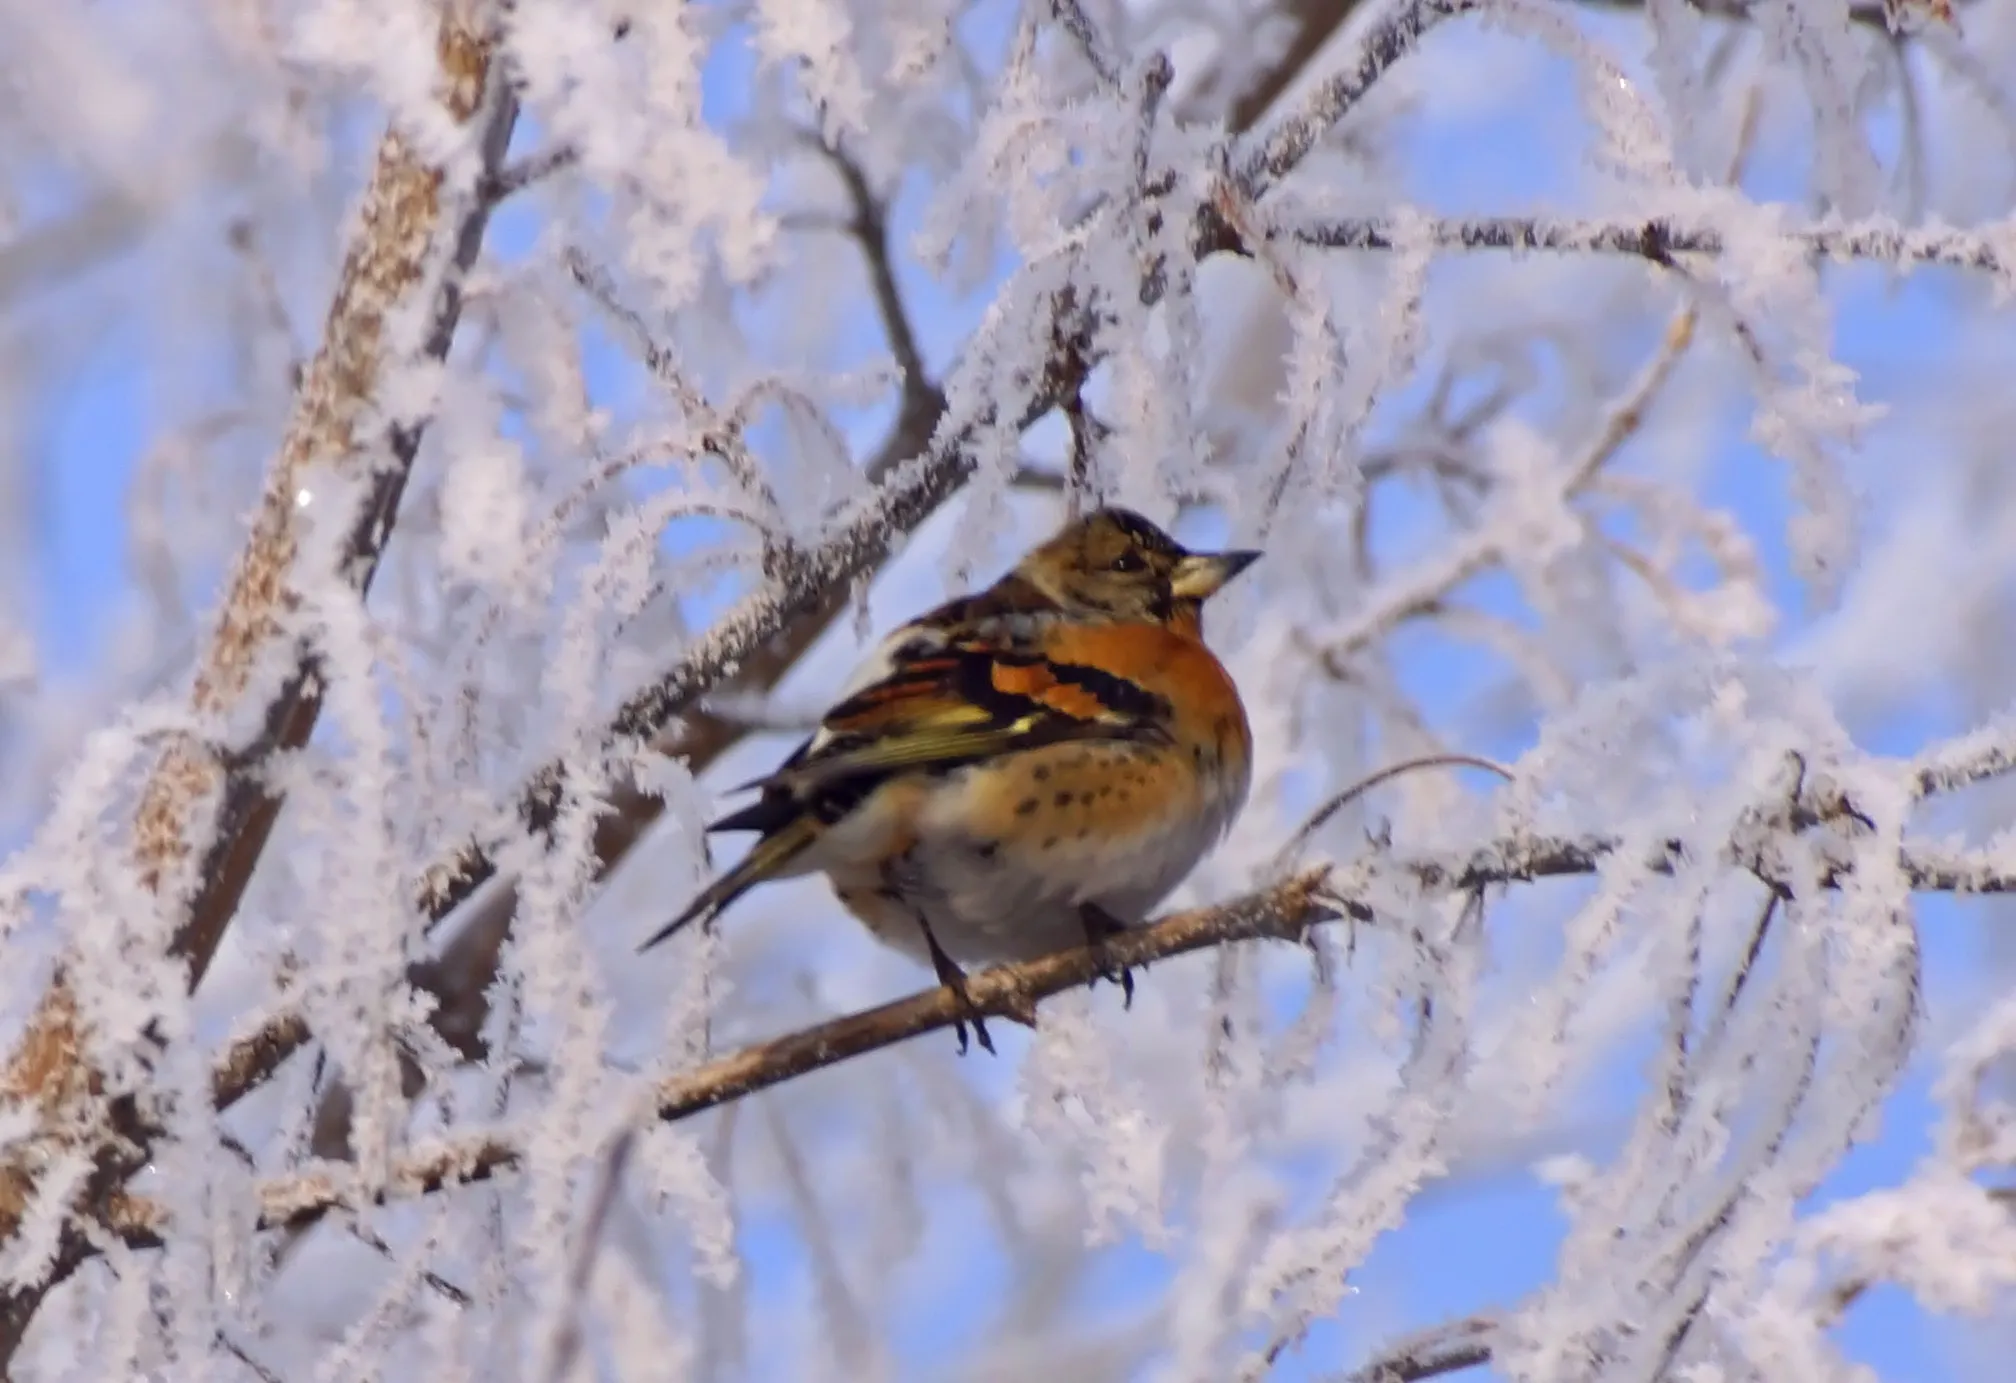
[1016,508,1260,629]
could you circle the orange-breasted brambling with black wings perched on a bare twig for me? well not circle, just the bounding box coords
[645,508,1260,1052]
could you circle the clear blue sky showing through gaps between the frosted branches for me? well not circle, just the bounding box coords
[7,6,1986,1383]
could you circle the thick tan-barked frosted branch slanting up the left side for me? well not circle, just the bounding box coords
[0,6,516,1359]
